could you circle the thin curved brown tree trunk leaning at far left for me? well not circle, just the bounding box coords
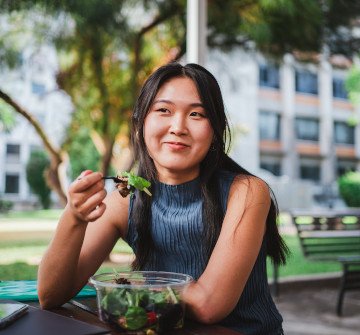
[0,90,66,206]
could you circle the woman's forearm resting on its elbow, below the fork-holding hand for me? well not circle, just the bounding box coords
[38,208,87,308]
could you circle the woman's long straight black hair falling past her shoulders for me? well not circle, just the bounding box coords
[131,63,288,269]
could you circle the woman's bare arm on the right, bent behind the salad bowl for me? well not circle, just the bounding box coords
[184,177,270,323]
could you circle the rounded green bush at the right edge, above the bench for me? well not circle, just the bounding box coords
[338,171,360,207]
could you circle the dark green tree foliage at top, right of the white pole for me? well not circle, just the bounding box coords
[208,0,360,56]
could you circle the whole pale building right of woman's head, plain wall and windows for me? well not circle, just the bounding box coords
[209,50,360,208]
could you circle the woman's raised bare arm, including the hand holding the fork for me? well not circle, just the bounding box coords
[38,173,129,308]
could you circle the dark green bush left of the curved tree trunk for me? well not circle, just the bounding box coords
[26,151,51,209]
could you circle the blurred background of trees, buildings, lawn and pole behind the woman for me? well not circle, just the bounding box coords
[0,0,360,334]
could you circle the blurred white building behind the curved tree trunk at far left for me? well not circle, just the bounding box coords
[0,46,72,205]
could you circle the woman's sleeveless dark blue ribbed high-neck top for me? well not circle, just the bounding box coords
[126,171,283,335]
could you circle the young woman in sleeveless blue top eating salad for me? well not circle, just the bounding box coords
[38,63,287,335]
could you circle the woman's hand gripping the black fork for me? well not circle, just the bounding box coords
[67,170,107,222]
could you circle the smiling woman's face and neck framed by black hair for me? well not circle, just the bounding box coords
[144,77,214,183]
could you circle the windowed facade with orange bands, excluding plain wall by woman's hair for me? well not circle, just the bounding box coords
[258,55,360,184]
